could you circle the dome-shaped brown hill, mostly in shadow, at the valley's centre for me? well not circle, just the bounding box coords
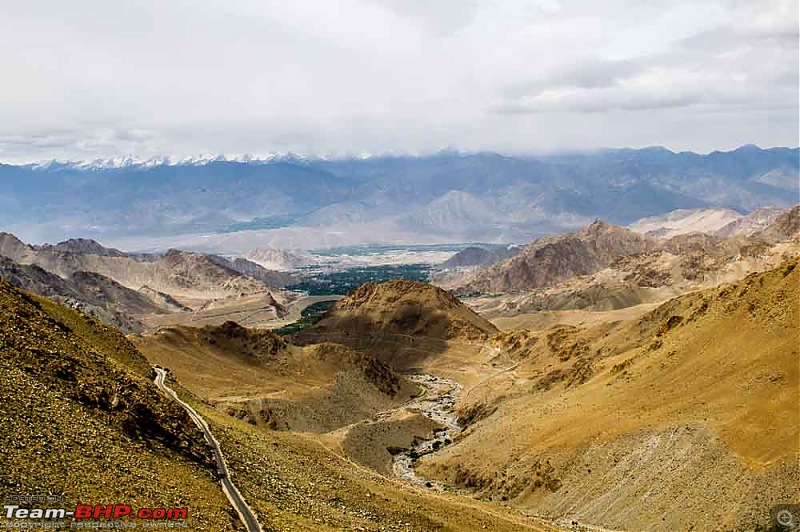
[295,279,497,368]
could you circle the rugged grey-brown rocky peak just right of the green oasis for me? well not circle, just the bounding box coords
[458,220,658,294]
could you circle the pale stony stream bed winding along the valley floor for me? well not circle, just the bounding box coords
[392,374,461,490]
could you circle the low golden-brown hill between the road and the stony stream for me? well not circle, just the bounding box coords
[134,322,416,432]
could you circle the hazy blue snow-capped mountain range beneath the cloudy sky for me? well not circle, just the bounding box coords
[0,146,800,253]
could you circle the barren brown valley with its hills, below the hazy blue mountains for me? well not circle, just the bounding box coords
[0,186,800,531]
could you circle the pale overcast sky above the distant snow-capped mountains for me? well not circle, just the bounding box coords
[0,0,798,162]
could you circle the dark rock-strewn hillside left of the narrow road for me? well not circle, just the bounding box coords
[0,280,235,530]
